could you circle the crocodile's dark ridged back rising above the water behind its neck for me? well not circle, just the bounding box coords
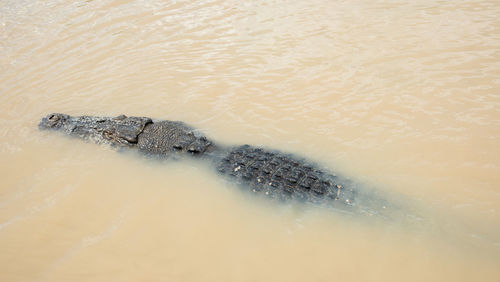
[217,145,354,205]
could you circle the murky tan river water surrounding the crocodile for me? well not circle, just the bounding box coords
[0,0,500,281]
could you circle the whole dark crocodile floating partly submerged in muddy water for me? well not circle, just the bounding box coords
[39,114,364,210]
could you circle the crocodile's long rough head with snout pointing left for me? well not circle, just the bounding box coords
[38,113,152,146]
